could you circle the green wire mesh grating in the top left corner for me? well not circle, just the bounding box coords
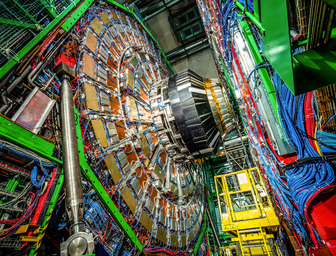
[0,0,72,67]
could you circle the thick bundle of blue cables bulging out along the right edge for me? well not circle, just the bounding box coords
[280,85,335,246]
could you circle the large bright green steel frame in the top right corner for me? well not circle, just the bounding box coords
[253,0,336,95]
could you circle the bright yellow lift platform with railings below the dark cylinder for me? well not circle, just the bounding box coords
[215,167,279,256]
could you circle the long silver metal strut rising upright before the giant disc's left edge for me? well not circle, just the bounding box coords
[61,75,84,233]
